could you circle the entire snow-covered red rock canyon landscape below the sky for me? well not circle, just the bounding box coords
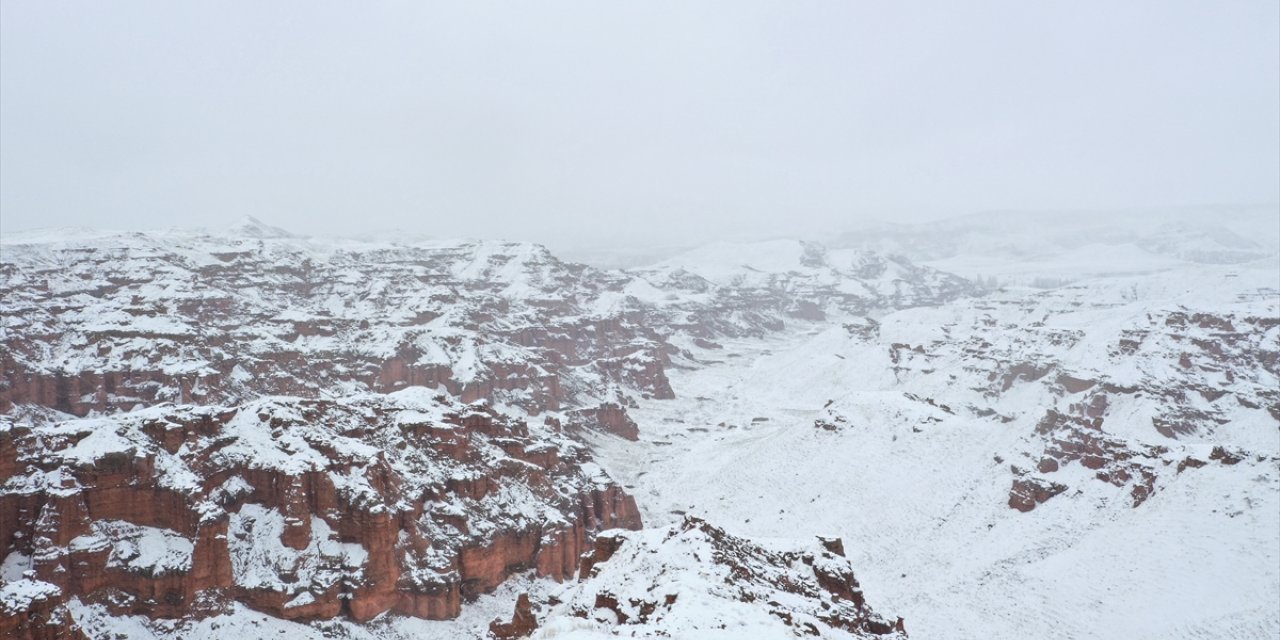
[0,210,1280,640]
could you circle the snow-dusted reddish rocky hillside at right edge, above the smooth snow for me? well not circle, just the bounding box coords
[890,269,1280,511]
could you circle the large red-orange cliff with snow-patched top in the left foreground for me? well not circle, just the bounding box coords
[0,388,640,621]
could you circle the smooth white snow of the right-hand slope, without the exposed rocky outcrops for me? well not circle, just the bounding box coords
[594,257,1280,639]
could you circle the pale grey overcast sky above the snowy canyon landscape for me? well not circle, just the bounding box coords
[0,0,1280,246]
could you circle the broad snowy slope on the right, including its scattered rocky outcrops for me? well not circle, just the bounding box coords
[586,256,1280,639]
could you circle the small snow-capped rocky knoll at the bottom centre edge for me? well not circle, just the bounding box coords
[535,517,906,639]
